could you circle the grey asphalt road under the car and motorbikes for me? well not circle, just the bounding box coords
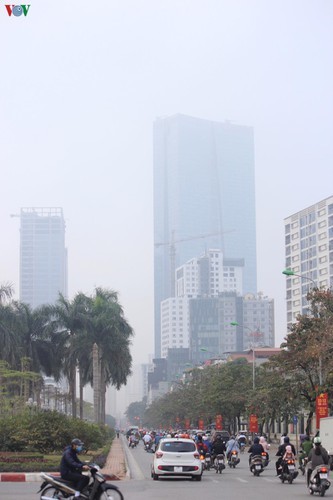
[0,445,312,500]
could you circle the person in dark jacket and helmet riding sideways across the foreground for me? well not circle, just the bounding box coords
[60,438,89,499]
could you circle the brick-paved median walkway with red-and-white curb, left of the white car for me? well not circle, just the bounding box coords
[0,436,129,483]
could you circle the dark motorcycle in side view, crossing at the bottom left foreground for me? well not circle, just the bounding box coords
[37,464,124,500]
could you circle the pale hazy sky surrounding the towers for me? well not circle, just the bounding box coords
[0,0,333,363]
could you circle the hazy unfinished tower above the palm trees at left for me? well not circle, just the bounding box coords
[20,208,67,308]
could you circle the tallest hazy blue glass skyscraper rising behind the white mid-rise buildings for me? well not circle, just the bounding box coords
[154,115,257,357]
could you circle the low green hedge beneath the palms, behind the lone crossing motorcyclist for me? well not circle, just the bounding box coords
[0,410,112,454]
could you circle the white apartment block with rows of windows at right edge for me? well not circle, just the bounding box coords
[284,196,333,327]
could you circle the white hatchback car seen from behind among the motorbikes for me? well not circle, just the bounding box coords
[151,438,202,481]
